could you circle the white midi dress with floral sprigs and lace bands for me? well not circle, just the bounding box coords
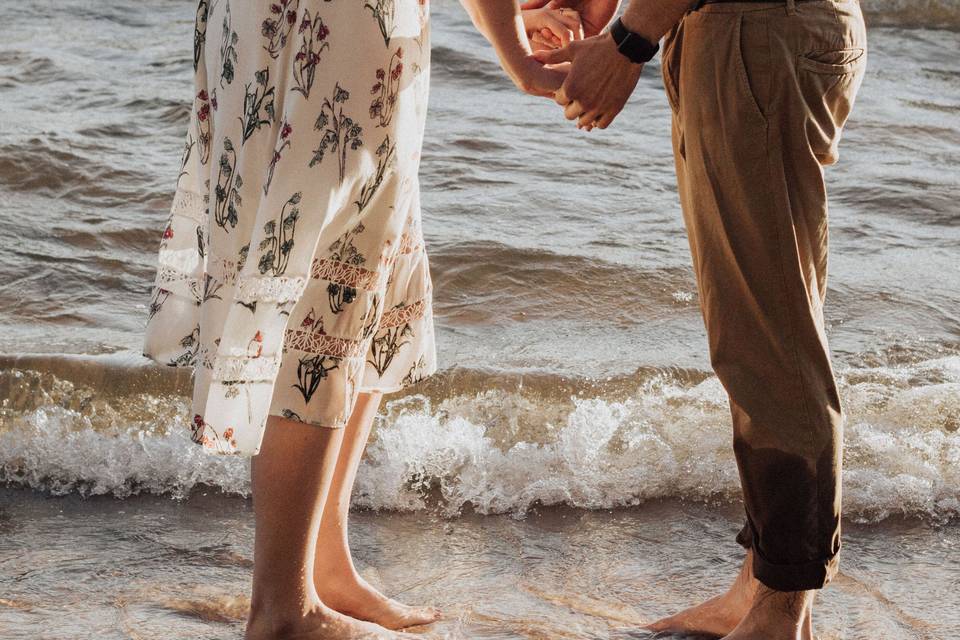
[144,0,436,455]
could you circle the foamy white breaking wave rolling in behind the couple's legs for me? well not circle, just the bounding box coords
[0,356,960,521]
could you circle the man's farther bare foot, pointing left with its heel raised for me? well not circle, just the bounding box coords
[647,551,762,637]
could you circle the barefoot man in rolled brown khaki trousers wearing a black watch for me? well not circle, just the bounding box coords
[527,0,867,640]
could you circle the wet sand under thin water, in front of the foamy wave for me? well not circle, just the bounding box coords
[0,489,960,640]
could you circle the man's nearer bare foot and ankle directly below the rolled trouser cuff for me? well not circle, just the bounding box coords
[724,586,816,640]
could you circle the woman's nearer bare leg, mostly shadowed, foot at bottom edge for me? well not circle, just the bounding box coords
[246,417,410,640]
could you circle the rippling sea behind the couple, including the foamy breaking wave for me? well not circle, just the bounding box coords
[0,0,960,520]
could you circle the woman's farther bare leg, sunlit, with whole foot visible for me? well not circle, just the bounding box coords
[314,393,440,629]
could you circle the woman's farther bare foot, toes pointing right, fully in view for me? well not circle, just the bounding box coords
[314,562,440,629]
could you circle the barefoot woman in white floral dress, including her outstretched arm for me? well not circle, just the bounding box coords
[144,0,569,639]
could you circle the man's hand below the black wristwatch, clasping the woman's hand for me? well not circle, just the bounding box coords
[533,33,643,130]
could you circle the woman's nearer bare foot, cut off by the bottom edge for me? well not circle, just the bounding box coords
[244,604,417,640]
